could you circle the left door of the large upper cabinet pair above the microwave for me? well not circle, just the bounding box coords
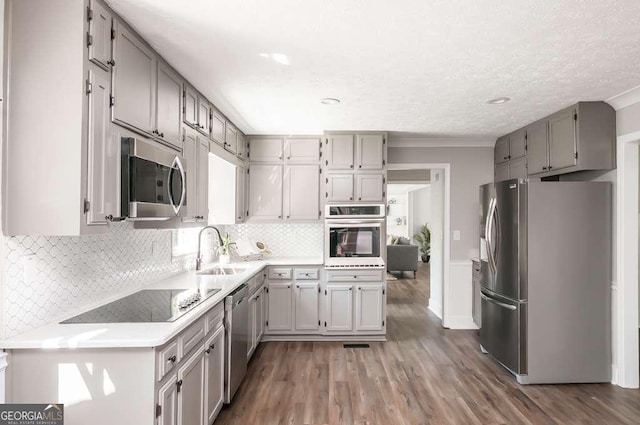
[113,25,156,133]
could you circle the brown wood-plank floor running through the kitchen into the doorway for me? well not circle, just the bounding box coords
[216,267,640,425]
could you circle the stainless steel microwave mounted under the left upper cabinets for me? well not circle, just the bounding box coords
[120,137,187,220]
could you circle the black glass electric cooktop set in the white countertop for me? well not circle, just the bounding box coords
[60,289,220,324]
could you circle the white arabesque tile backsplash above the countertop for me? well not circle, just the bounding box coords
[0,222,323,337]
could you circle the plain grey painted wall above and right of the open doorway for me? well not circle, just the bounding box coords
[388,145,493,260]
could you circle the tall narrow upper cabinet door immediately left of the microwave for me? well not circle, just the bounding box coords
[87,69,120,225]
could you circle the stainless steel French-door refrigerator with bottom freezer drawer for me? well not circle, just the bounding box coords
[480,180,612,384]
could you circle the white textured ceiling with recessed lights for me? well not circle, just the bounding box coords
[107,0,640,137]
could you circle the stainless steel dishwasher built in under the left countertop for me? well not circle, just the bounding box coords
[224,284,249,403]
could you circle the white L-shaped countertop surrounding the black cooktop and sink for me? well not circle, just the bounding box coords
[0,257,323,350]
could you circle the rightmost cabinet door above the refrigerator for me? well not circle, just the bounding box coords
[549,109,577,170]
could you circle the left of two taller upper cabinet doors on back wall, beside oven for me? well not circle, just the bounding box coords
[249,164,282,220]
